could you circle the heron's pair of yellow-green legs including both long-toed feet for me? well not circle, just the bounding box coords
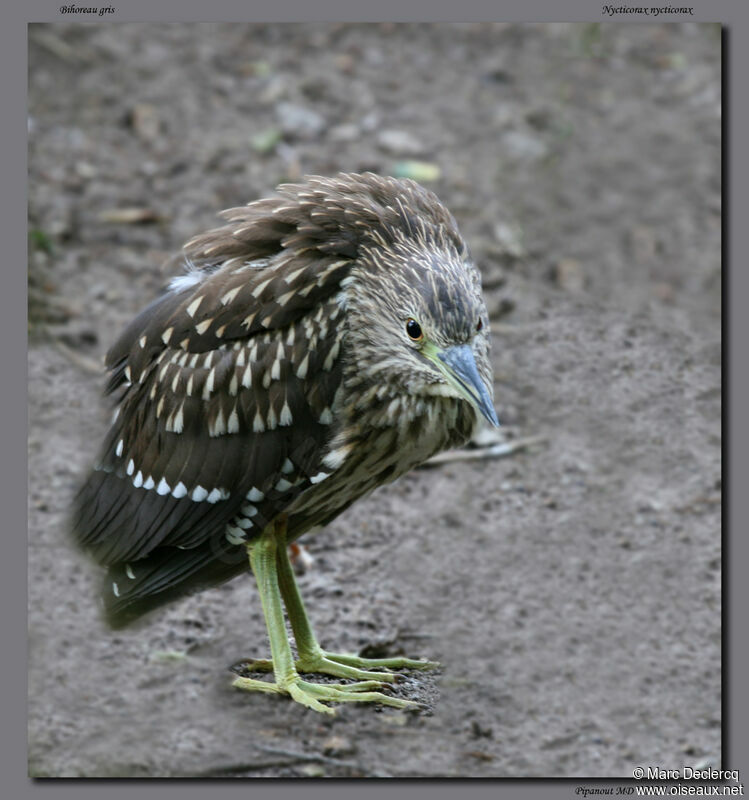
[233,524,432,714]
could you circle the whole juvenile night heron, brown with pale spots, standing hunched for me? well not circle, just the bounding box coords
[73,173,498,713]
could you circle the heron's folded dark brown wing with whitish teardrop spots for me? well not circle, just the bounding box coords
[75,247,348,564]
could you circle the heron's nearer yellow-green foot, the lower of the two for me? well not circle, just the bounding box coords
[232,662,422,715]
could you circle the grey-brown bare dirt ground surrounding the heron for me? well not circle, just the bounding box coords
[28,24,721,777]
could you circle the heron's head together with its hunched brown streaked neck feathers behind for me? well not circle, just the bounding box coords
[193,173,498,432]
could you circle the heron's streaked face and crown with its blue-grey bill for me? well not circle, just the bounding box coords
[347,232,499,425]
